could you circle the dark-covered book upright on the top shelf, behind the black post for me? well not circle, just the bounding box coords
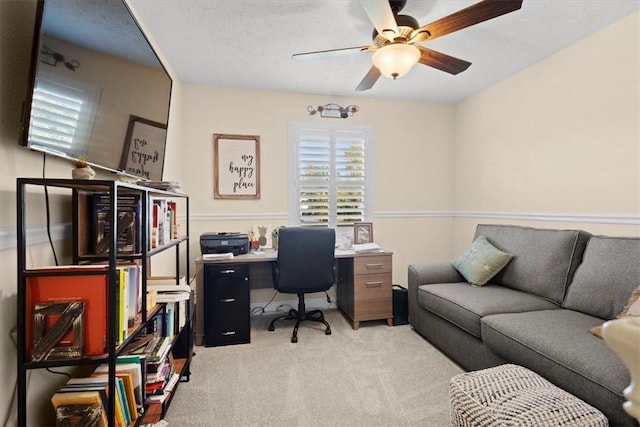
[93,193,142,255]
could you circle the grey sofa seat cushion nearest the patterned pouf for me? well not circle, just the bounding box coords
[482,309,632,425]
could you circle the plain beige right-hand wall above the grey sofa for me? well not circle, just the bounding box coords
[454,13,640,251]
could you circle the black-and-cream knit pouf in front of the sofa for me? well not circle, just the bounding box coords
[449,365,609,427]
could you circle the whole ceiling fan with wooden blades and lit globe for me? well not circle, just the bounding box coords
[292,0,522,91]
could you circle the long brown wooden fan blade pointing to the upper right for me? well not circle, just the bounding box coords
[417,0,522,40]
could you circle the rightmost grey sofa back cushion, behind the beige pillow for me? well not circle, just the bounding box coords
[563,236,640,320]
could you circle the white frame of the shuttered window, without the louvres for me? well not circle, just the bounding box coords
[287,122,374,230]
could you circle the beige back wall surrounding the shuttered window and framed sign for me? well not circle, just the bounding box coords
[183,85,453,302]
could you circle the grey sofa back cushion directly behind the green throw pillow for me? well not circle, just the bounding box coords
[476,224,590,305]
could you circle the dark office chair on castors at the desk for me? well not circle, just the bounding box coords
[269,227,336,343]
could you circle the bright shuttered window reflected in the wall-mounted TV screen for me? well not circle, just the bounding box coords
[29,72,100,157]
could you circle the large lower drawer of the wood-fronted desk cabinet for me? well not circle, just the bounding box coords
[354,273,393,320]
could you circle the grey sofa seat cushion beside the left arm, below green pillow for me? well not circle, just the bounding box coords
[418,282,559,338]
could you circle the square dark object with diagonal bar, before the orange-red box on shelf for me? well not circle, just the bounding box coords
[31,301,84,362]
